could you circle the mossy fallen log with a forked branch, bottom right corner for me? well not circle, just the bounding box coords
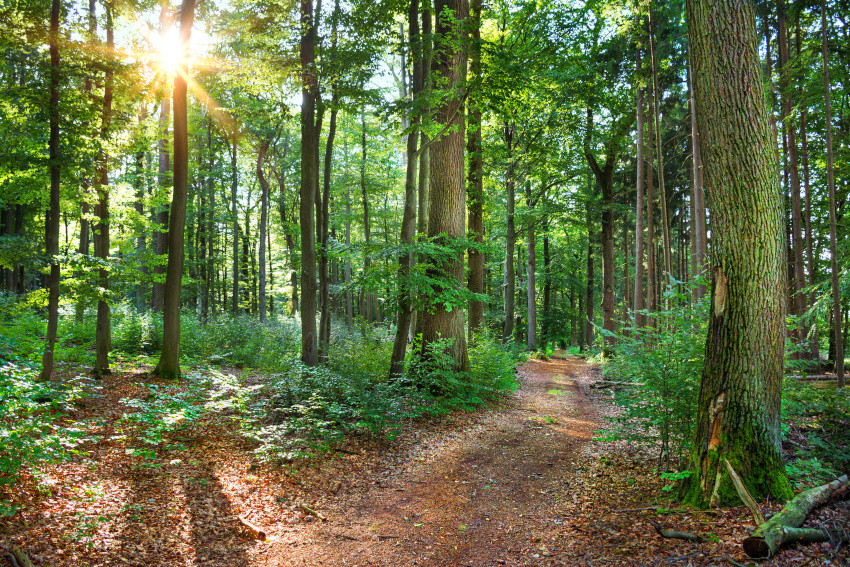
[743,475,847,559]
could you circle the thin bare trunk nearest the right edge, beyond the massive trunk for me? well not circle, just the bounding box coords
[820,0,845,388]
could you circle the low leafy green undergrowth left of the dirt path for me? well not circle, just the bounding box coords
[0,301,521,500]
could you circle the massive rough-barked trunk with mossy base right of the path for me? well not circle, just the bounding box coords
[687,0,793,505]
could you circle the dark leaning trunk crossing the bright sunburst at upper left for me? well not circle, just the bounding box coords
[153,0,195,378]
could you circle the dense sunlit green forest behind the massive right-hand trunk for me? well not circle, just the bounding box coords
[0,0,850,524]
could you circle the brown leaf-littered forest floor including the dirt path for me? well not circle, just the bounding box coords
[0,357,850,567]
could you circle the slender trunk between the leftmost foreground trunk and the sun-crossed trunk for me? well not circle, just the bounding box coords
[93,2,115,376]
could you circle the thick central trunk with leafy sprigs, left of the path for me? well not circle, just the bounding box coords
[422,0,469,370]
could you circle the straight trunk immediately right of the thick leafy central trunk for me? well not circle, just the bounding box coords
[467,0,484,342]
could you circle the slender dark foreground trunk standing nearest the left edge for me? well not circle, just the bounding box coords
[39,0,62,381]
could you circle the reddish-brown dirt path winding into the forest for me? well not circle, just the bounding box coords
[276,358,598,566]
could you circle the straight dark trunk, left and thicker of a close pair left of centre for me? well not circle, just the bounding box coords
[299,0,319,366]
